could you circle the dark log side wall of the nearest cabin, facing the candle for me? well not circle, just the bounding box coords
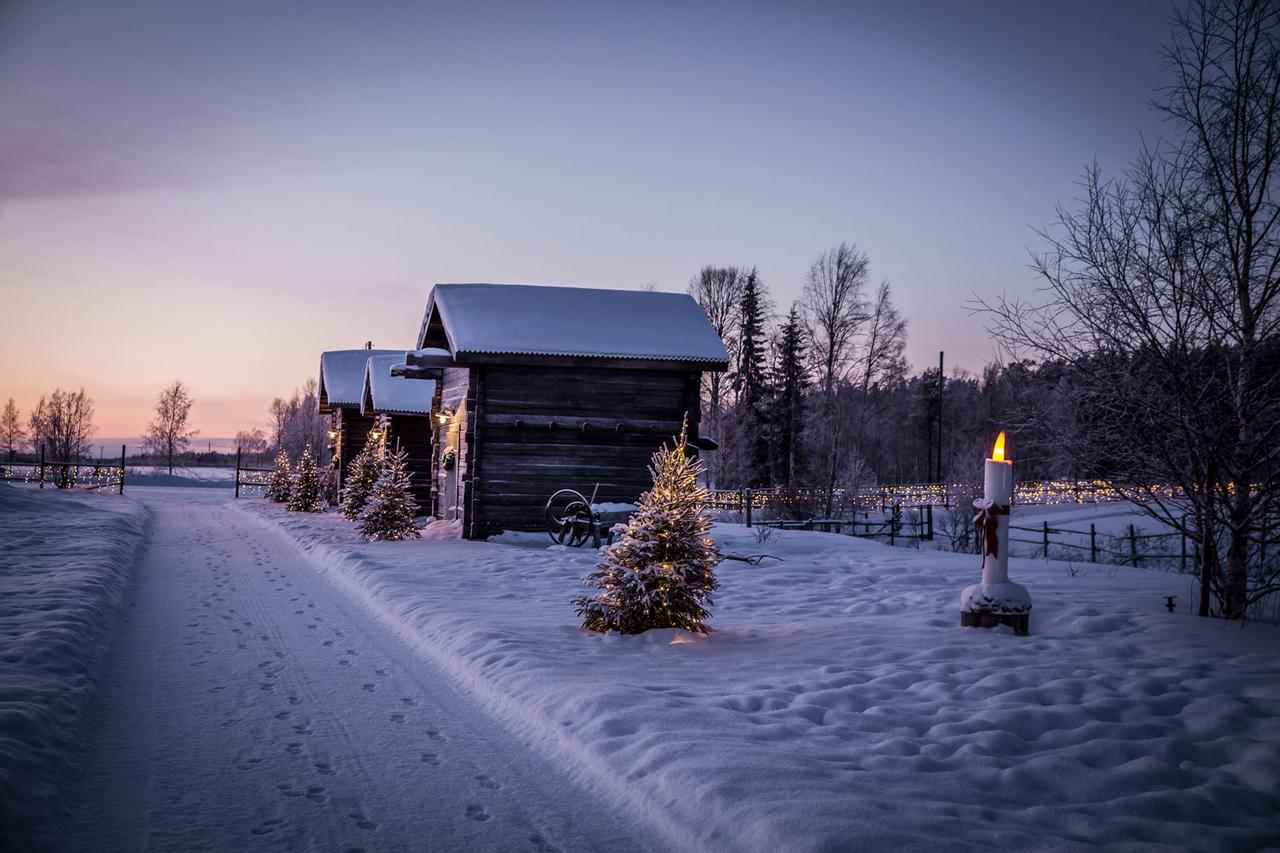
[463,365,699,538]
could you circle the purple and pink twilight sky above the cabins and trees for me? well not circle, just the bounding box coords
[0,0,1170,437]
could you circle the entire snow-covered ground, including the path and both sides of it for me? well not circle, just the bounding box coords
[0,487,1280,850]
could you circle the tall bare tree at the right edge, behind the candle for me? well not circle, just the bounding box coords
[980,0,1280,619]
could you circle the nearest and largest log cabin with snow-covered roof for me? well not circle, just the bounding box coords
[398,284,728,538]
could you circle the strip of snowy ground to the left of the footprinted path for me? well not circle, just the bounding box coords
[0,483,146,849]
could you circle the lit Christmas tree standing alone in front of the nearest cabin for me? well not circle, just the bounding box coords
[573,421,721,634]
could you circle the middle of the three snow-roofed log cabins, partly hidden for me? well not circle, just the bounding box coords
[360,352,435,515]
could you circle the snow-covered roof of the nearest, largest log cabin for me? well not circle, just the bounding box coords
[417,284,728,369]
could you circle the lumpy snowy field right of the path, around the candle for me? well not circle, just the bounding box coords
[249,501,1280,850]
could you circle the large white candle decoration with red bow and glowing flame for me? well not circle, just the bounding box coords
[960,433,1032,634]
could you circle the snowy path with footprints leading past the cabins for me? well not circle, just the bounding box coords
[59,489,648,850]
